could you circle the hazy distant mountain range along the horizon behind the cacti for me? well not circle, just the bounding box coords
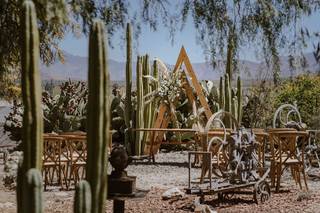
[40,53,320,81]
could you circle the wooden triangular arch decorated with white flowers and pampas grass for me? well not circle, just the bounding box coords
[144,46,212,157]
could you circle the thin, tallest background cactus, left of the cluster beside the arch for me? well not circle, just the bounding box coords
[125,23,132,152]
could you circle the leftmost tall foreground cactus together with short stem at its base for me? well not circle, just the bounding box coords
[17,1,43,213]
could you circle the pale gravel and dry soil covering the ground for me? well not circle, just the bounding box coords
[0,152,320,213]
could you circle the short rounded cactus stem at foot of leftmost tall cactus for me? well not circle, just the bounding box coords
[23,168,43,213]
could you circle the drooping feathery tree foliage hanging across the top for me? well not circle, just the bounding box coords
[0,0,320,84]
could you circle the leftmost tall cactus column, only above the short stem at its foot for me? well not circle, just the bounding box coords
[21,1,43,173]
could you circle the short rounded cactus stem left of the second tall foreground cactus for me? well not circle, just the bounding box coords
[74,180,91,213]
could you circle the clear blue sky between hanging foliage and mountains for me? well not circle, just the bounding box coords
[61,10,320,64]
